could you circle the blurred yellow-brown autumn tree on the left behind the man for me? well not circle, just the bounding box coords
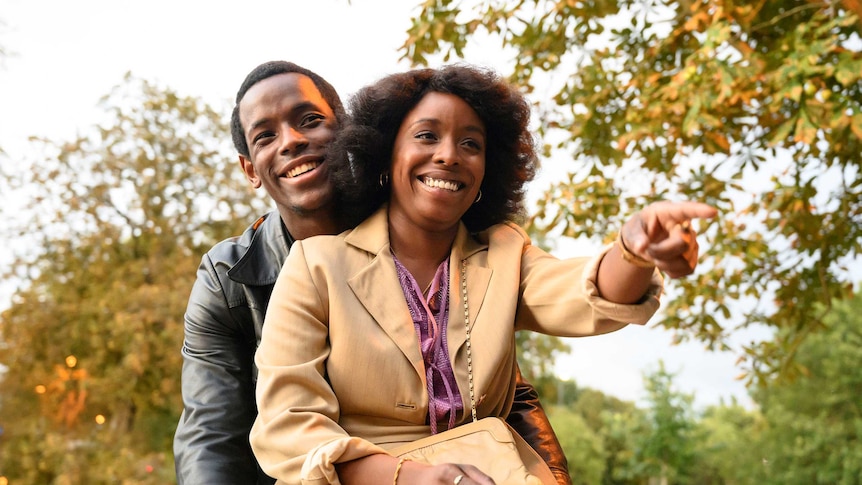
[0,76,263,483]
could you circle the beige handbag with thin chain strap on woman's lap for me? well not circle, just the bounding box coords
[389,261,557,485]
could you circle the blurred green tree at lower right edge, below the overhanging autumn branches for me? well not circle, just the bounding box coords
[754,294,862,485]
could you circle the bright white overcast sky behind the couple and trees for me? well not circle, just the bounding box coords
[0,0,750,406]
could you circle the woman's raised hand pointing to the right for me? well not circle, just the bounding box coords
[620,202,718,278]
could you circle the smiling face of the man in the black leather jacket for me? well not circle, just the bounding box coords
[239,73,337,216]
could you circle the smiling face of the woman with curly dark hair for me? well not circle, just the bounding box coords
[389,92,486,231]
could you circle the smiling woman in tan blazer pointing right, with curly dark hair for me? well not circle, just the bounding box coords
[251,65,715,485]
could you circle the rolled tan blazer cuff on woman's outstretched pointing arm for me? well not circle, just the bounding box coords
[582,244,664,325]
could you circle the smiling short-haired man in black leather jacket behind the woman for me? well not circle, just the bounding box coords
[174,61,571,485]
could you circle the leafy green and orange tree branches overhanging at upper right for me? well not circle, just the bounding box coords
[402,0,862,382]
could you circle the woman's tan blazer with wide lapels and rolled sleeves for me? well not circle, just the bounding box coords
[251,207,661,484]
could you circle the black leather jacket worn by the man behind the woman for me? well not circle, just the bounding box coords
[174,212,571,485]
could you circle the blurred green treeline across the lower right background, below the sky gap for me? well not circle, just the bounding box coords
[549,293,862,485]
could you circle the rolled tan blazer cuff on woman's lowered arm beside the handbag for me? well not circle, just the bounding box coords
[300,437,386,485]
